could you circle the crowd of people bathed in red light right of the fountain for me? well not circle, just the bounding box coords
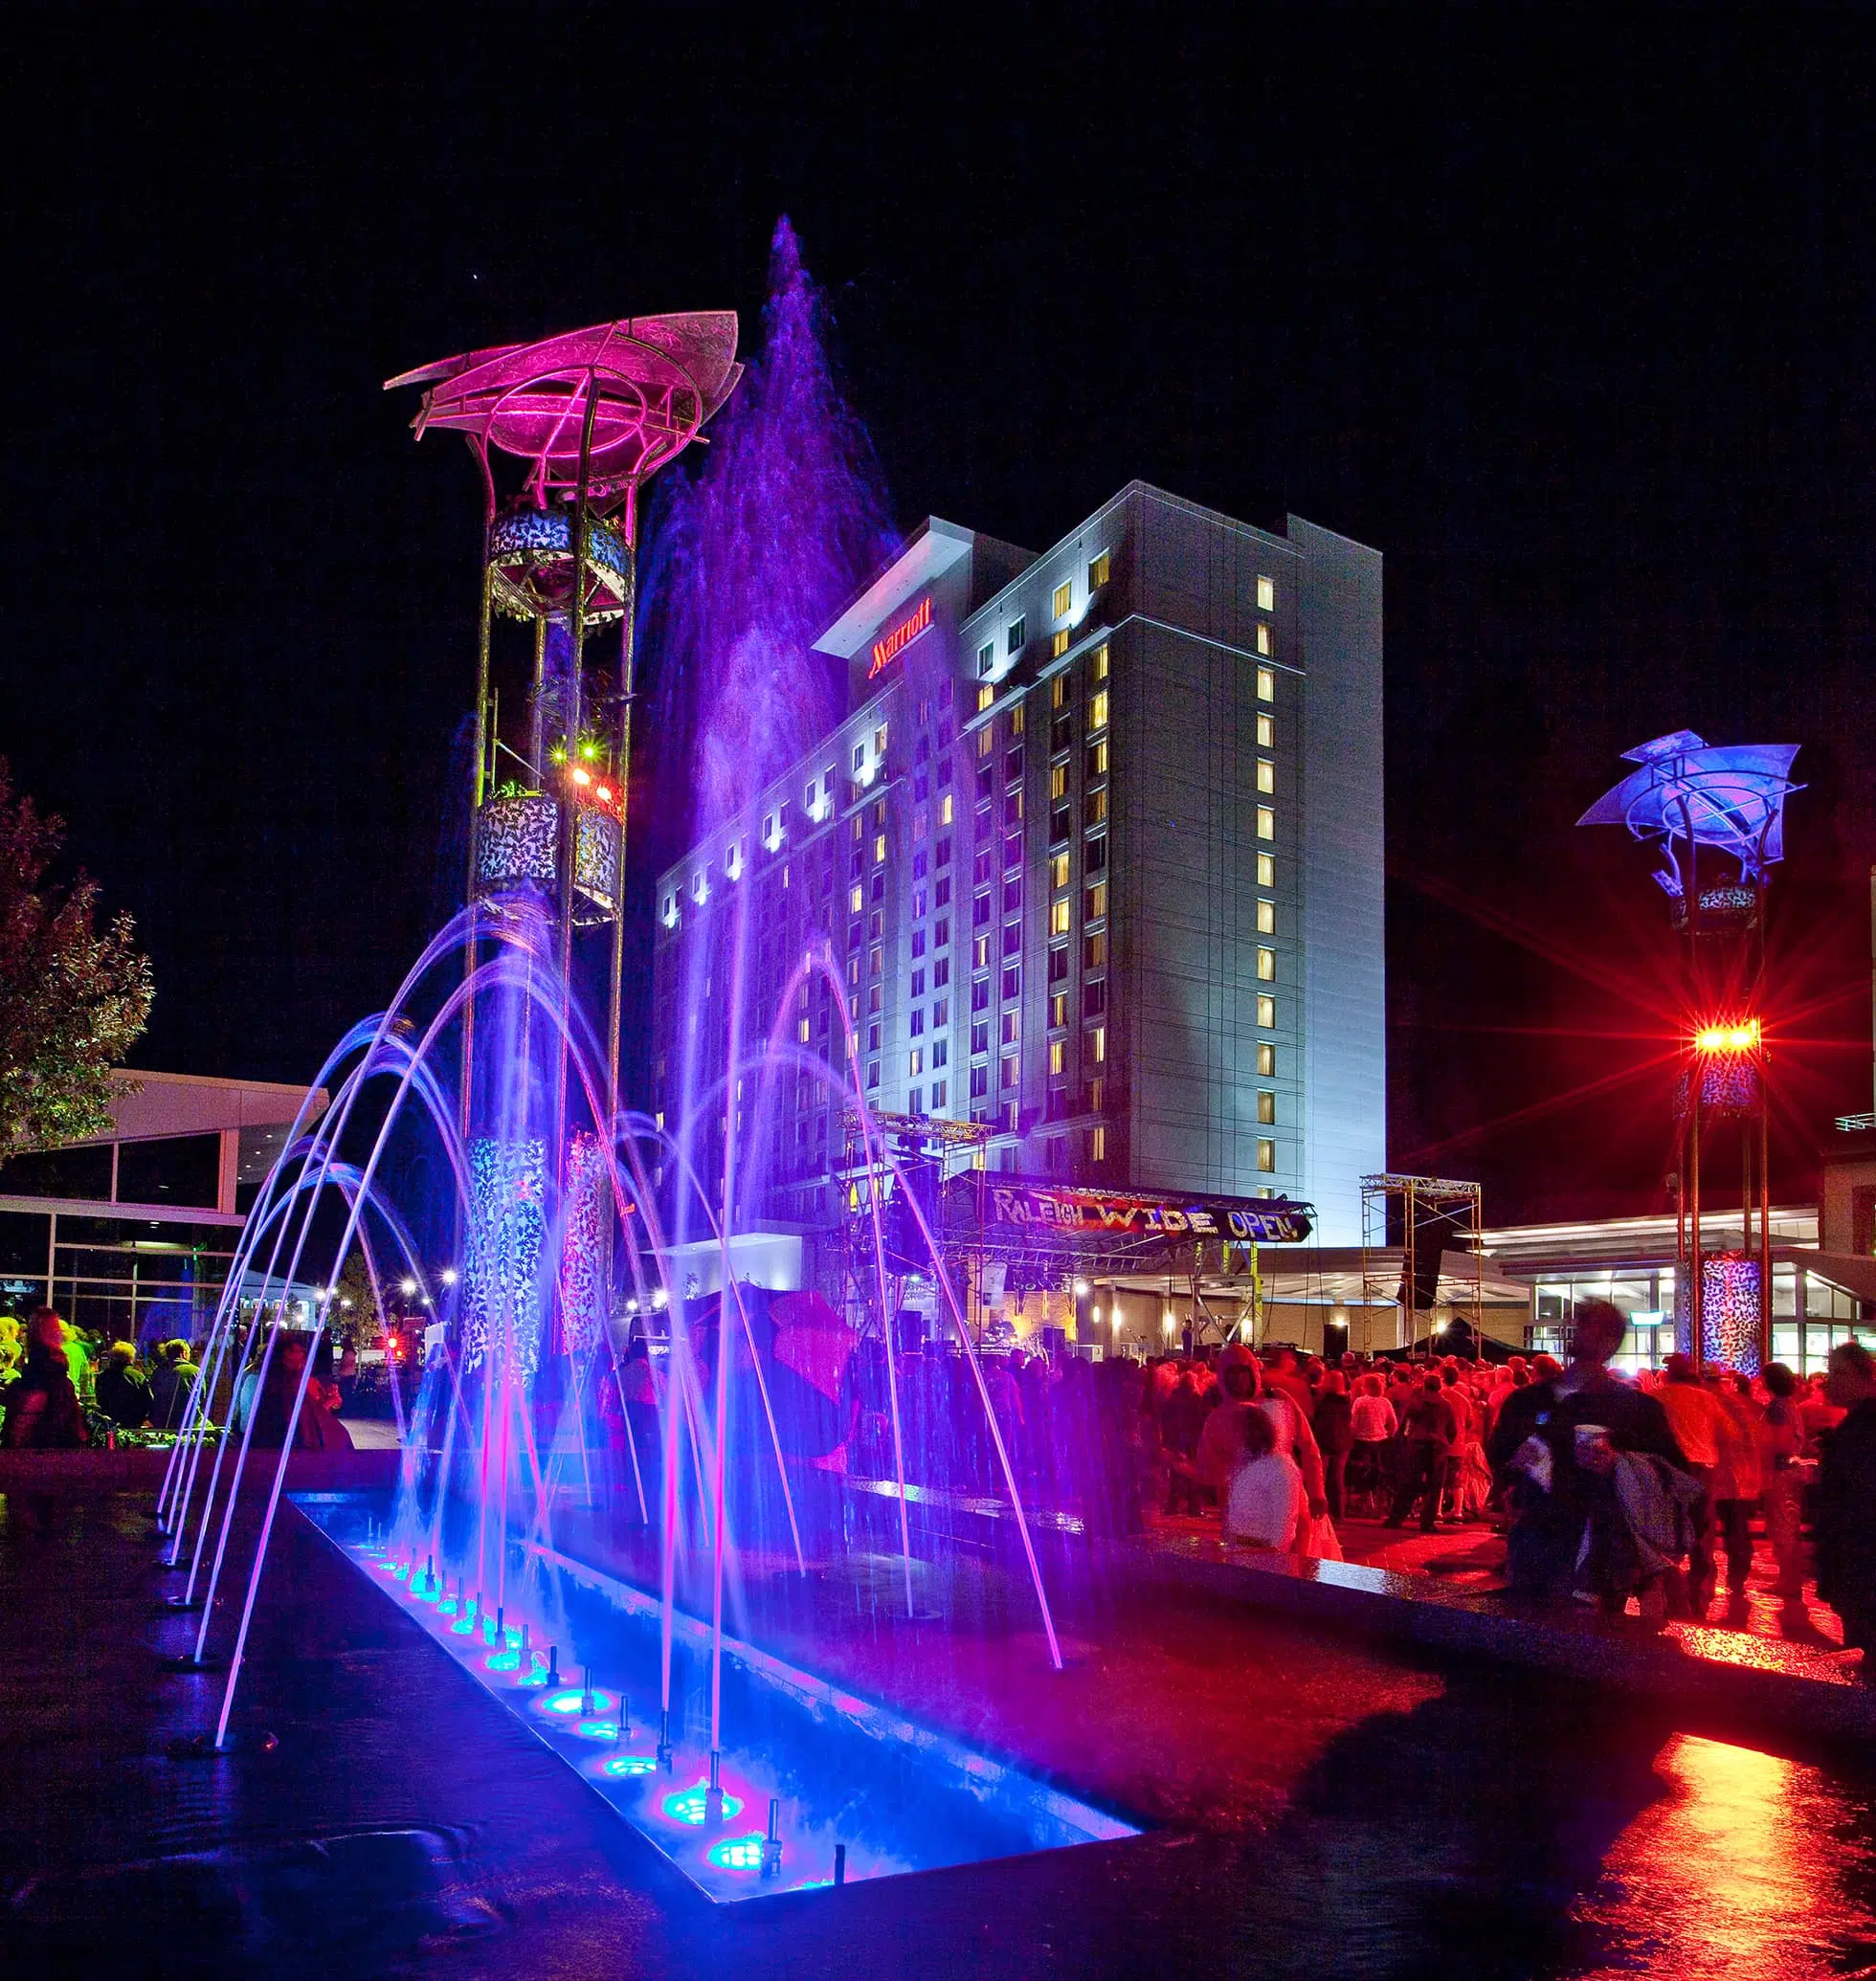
[1101,1302,1876,1664]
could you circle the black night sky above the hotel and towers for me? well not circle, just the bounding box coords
[0,6,1876,1222]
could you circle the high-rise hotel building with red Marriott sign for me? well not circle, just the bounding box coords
[652,481,1387,1244]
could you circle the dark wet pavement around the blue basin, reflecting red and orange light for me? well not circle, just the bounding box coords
[0,1496,1876,1981]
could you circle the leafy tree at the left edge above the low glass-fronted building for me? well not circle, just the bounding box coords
[0,757,157,1159]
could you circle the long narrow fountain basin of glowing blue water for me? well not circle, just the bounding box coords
[297,1494,1139,1902]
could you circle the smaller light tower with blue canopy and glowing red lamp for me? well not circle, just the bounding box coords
[1576,729,1802,1375]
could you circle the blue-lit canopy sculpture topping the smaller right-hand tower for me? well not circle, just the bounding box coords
[1576,729,1800,905]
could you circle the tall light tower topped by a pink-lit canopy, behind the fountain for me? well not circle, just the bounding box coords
[387,321,743,1375]
